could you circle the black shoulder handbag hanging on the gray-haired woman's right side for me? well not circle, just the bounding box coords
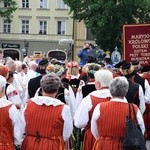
[123,103,147,150]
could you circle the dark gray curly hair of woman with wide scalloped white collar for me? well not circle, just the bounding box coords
[40,73,61,93]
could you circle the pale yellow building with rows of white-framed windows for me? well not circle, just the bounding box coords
[0,0,73,59]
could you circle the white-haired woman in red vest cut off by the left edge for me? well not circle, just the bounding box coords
[0,75,24,150]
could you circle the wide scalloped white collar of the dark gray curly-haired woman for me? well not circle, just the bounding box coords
[31,96,64,106]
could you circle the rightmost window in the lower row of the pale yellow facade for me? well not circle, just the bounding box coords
[57,21,66,35]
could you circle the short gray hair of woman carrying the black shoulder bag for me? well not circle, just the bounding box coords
[109,77,129,97]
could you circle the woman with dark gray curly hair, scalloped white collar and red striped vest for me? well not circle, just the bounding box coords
[22,73,73,150]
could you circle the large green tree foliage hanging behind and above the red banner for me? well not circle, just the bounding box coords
[64,0,150,50]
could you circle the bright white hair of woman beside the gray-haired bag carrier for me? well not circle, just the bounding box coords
[95,69,113,87]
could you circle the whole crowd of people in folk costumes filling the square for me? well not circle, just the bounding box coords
[0,47,150,150]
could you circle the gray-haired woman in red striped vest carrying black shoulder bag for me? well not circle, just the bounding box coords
[91,77,145,150]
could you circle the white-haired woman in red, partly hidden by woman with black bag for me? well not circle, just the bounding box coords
[74,69,113,150]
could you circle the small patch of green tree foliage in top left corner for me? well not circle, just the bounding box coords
[0,0,17,19]
